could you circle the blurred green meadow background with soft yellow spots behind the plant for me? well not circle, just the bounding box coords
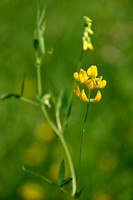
[0,0,133,200]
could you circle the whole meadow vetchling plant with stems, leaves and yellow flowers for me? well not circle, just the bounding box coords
[1,5,107,198]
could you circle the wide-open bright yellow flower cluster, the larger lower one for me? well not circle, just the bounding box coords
[73,65,107,102]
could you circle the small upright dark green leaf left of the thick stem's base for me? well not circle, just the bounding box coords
[58,160,65,187]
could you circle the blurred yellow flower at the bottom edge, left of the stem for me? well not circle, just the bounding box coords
[18,182,44,200]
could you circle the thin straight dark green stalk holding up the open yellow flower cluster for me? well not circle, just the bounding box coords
[77,90,91,182]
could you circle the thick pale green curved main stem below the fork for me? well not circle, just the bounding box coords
[59,134,76,196]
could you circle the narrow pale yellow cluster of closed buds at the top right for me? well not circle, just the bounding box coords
[82,16,94,51]
